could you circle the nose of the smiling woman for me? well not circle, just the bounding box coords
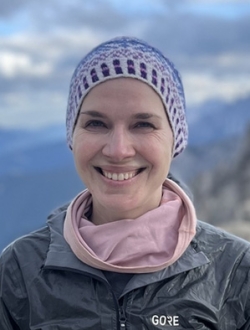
[102,128,136,162]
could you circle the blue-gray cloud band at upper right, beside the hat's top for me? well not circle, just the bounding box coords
[145,13,250,57]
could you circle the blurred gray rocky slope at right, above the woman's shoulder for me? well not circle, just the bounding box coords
[189,125,250,240]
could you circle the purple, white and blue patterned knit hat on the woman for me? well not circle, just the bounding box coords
[66,37,188,157]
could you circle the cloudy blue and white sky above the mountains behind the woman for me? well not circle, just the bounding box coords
[0,0,250,129]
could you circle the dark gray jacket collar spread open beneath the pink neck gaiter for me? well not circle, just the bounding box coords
[44,208,209,294]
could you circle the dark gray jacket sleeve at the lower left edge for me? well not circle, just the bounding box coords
[0,246,28,330]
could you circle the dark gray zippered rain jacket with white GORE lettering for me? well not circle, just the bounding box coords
[0,207,250,330]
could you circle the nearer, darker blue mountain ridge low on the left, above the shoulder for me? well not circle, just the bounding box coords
[0,167,84,250]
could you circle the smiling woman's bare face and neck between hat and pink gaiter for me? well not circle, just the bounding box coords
[73,78,173,220]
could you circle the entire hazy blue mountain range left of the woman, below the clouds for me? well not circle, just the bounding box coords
[0,133,85,250]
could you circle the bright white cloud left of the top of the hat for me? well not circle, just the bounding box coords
[0,28,102,79]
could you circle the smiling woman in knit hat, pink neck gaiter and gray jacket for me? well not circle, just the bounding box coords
[0,37,250,330]
